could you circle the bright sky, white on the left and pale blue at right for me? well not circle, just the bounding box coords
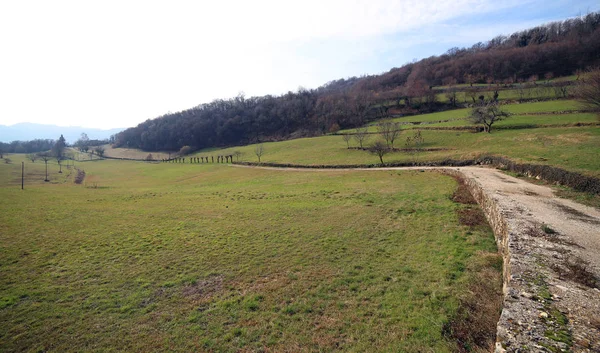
[0,0,600,129]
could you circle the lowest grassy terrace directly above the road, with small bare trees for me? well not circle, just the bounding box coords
[211,126,600,177]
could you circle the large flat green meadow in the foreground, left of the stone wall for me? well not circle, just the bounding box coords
[0,155,499,352]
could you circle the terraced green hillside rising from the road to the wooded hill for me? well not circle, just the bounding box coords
[206,100,600,177]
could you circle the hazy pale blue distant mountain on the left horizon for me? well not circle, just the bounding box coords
[0,123,125,143]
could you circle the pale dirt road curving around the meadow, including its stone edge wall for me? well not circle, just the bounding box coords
[231,165,600,352]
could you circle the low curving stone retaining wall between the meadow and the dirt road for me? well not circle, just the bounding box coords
[440,168,570,353]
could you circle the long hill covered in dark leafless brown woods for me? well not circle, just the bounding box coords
[115,13,600,151]
